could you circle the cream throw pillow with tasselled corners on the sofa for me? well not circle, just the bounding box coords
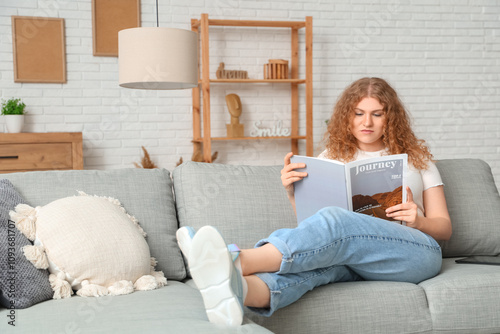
[10,193,166,299]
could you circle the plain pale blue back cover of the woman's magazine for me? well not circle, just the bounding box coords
[291,155,349,223]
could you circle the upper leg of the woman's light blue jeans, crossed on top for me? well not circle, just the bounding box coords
[256,207,441,283]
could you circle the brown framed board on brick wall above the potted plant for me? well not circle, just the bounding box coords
[12,16,66,83]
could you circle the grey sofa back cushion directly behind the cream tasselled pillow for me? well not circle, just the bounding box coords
[1,168,186,280]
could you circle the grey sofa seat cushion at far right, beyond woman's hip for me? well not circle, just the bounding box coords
[420,258,500,333]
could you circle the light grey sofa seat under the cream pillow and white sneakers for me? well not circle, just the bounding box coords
[0,281,270,334]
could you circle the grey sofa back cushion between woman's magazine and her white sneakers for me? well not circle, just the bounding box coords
[172,161,297,248]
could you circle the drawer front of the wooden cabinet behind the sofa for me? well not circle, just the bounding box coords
[0,143,73,171]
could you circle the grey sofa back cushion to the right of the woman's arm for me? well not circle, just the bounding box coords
[436,159,500,257]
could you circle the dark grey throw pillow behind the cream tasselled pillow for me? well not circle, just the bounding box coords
[0,179,52,309]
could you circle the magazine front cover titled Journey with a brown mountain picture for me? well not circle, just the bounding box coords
[346,154,408,221]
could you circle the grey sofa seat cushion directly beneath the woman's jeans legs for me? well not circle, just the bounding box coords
[246,281,432,334]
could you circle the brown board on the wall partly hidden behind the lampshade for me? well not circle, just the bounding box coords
[92,0,141,57]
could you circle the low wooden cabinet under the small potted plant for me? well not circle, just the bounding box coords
[0,132,83,173]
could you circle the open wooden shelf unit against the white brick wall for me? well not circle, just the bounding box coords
[191,14,314,162]
